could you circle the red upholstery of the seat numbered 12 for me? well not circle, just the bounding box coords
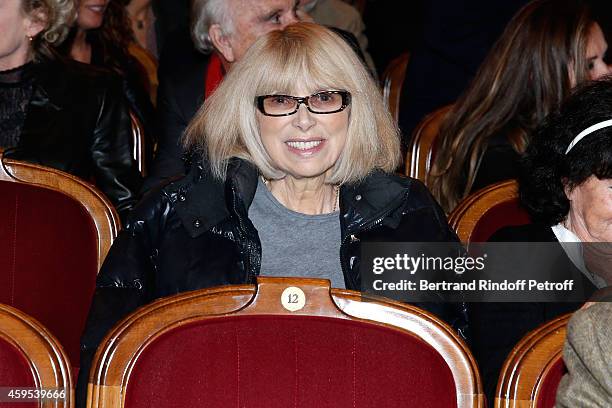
[125,316,457,408]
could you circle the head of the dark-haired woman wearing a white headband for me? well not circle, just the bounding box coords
[520,80,612,242]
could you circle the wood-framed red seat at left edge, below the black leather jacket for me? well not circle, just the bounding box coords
[0,152,119,368]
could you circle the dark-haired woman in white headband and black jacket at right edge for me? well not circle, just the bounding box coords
[470,80,612,397]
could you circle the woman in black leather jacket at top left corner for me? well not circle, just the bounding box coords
[0,0,141,216]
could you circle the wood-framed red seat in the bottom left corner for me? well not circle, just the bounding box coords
[0,304,74,408]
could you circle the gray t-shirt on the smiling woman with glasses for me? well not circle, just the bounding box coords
[249,180,345,288]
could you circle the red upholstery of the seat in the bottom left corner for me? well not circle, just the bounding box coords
[0,337,38,408]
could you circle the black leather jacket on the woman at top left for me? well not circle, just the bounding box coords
[5,60,142,215]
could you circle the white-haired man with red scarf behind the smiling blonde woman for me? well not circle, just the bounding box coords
[145,0,299,189]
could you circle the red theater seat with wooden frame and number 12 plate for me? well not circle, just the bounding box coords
[87,278,483,408]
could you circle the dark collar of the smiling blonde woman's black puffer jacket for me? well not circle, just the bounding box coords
[170,159,412,238]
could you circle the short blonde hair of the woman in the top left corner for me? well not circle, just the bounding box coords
[19,0,76,58]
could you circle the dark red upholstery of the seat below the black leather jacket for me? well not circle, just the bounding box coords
[0,181,97,366]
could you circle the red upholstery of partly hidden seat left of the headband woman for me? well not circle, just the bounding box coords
[470,200,530,242]
